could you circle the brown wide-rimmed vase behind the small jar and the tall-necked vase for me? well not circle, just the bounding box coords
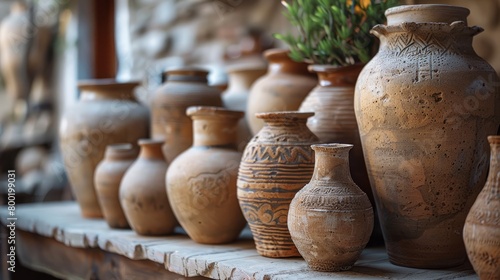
[151,68,222,162]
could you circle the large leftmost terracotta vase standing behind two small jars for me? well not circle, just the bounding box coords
[59,80,149,217]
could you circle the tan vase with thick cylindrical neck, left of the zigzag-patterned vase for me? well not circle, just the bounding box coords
[166,107,246,244]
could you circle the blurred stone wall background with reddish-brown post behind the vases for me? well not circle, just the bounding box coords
[0,0,500,204]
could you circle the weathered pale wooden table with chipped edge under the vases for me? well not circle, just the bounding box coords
[0,202,477,280]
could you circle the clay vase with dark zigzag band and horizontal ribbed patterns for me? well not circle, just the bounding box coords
[238,112,318,258]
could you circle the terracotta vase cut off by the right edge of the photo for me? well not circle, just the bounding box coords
[463,136,500,279]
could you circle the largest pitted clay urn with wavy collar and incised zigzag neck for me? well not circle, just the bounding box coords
[355,5,500,268]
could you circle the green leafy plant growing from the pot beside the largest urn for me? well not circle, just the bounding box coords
[274,0,399,66]
